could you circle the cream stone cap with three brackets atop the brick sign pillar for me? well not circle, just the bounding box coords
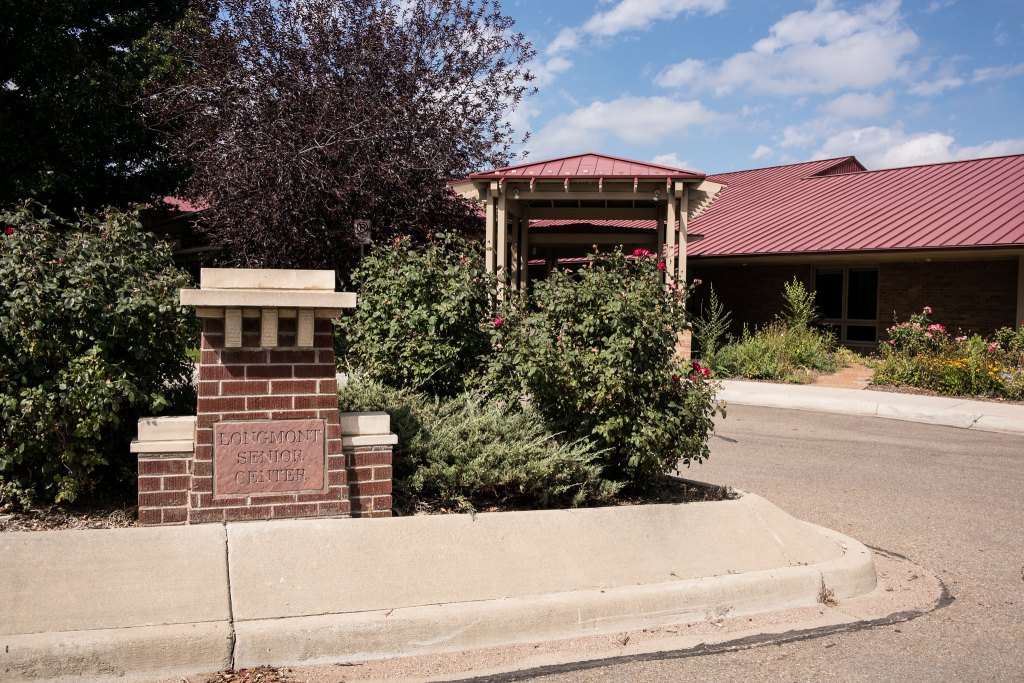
[181,268,355,348]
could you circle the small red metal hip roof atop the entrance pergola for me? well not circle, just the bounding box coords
[469,153,705,180]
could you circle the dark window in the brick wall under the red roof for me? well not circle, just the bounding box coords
[814,266,879,344]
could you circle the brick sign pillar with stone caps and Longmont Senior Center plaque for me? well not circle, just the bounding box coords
[133,268,393,524]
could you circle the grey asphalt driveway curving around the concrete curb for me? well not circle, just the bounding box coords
[537,405,1024,682]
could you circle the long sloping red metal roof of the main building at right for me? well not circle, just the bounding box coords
[688,155,1024,257]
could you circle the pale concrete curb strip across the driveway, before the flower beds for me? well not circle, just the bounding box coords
[719,380,1024,434]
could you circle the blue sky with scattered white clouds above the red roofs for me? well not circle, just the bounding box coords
[503,0,1024,173]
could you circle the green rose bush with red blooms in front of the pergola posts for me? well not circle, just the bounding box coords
[488,250,719,489]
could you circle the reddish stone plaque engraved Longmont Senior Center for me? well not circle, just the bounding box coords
[213,420,327,497]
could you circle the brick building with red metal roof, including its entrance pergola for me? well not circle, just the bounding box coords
[453,154,1024,346]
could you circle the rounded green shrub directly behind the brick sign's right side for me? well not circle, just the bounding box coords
[337,233,492,396]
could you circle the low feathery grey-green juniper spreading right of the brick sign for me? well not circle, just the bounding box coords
[339,376,620,511]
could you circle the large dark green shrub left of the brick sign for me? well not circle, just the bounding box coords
[0,204,199,502]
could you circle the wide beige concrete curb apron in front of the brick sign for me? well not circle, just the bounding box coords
[0,495,876,681]
